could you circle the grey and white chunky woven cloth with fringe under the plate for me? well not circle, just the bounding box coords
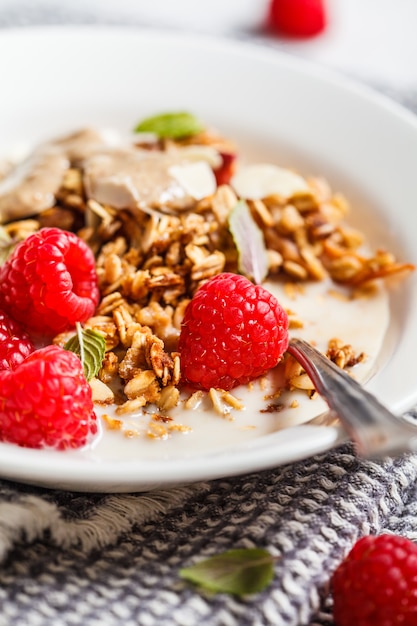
[0,438,417,626]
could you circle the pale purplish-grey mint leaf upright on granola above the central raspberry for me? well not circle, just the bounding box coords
[229,200,268,285]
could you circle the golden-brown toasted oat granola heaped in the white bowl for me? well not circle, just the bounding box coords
[3,127,412,428]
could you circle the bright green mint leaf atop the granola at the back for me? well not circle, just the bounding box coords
[135,112,204,139]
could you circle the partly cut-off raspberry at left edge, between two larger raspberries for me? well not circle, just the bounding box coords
[0,310,34,370]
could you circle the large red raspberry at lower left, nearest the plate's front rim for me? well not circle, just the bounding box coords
[0,345,97,450]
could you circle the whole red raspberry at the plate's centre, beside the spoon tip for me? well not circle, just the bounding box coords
[179,273,288,390]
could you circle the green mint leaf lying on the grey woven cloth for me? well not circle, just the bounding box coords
[179,548,275,596]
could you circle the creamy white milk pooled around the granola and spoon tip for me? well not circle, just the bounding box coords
[83,281,389,461]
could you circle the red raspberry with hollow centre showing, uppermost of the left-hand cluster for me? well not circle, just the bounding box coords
[0,228,99,335]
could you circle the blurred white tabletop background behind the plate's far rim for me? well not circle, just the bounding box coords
[0,0,417,106]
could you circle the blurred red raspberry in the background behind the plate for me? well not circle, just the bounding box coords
[268,0,327,37]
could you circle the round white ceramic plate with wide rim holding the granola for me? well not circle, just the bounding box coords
[0,28,417,492]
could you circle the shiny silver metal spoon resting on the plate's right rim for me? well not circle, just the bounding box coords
[288,339,417,458]
